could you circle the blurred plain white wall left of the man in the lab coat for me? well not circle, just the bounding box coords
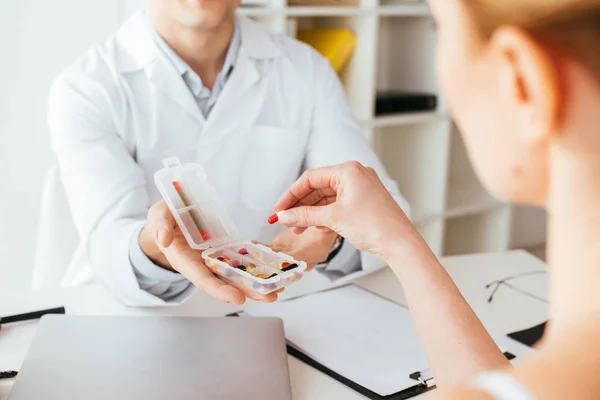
[0,0,125,290]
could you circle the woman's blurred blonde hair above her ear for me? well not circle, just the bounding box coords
[463,0,600,79]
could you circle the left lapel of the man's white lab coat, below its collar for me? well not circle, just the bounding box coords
[146,56,205,125]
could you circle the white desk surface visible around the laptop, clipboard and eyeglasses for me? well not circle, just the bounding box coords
[0,251,548,400]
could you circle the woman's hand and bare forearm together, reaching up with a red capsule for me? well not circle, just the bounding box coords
[275,162,510,387]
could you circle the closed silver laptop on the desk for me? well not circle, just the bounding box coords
[8,315,292,400]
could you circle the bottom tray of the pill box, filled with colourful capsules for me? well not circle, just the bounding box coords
[202,241,306,294]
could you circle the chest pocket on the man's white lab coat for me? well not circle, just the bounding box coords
[241,126,306,211]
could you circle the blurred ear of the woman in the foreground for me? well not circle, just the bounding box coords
[490,26,564,145]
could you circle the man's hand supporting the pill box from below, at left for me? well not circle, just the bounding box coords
[139,201,277,304]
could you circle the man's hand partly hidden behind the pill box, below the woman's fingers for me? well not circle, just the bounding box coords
[267,228,338,271]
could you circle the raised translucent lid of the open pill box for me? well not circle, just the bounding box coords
[154,157,237,250]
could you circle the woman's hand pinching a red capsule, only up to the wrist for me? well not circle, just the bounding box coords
[275,161,428,261]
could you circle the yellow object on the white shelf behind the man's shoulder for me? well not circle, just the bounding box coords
[298,28,356,73]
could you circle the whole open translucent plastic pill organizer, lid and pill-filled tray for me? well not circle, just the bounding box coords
[154,158,306,294]
